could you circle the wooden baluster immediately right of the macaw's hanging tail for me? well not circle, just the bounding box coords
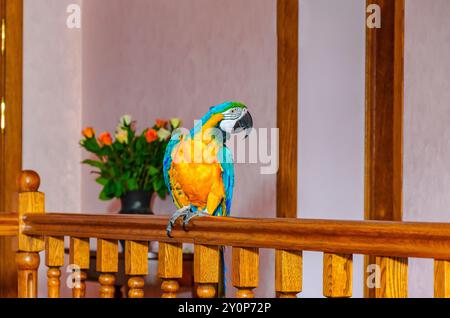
[232,247,259,298]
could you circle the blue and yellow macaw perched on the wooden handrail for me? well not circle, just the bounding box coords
[163,102,253,236]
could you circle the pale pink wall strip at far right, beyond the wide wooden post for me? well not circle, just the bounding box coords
[404,0,450,297]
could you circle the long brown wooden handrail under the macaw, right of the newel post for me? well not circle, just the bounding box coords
[23,213,450,260]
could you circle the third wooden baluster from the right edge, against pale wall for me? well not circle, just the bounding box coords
[323,253,353,298]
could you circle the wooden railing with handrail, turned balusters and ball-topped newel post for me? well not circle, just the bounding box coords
[0,172,450,298]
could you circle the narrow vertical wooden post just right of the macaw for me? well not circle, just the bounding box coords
[277,0,299,218]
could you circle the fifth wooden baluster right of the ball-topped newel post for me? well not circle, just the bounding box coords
[158,242,183,298]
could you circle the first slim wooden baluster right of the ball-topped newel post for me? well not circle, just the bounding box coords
[45,237,64,298]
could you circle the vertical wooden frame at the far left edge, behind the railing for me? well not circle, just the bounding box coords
[0,0,23,297]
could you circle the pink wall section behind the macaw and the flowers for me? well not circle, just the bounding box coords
[82,0,276,296]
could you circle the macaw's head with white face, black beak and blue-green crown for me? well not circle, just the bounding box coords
[210,102,253,138]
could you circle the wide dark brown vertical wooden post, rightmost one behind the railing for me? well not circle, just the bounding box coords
[364,0,405,297]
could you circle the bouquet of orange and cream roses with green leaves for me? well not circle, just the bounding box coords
[80,115,181,213]
